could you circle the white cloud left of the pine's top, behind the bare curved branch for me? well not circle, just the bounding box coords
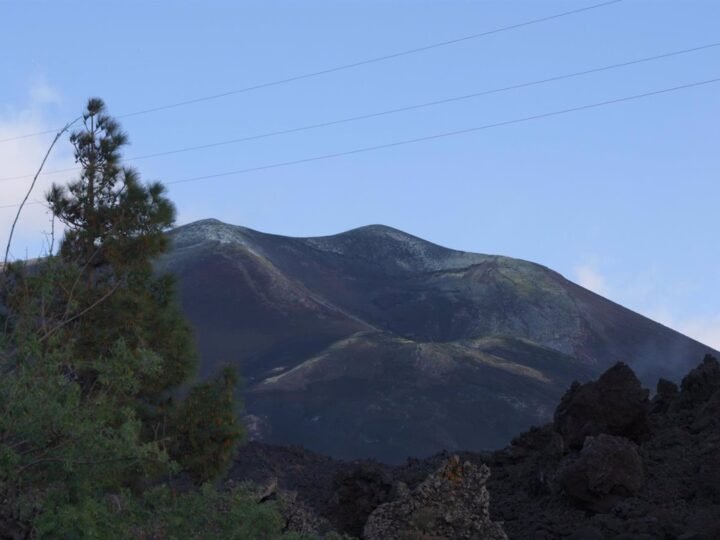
[0,87,73,262]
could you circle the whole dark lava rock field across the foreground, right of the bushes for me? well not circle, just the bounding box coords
[229,356,720,540]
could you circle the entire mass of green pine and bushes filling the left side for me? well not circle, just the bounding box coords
[0,100,270,539]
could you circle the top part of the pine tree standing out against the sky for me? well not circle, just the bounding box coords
[47,98,175,279]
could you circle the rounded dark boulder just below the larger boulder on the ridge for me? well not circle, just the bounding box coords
[558,433,645,511]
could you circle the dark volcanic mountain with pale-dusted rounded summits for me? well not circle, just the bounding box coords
[159,220,715,462]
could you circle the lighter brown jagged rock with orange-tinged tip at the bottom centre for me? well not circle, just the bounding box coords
[363,456,507,540]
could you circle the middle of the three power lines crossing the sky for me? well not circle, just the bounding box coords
[0,42,720,182]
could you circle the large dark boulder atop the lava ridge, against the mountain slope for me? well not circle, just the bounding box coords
[554,362,650,449]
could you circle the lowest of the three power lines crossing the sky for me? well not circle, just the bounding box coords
[0,77,720,215]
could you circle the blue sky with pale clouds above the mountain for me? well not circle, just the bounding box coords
[0,0,720,348]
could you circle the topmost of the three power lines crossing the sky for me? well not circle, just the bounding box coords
[0,0,623,143]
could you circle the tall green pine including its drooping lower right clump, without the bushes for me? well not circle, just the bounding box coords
[47,99,248,481]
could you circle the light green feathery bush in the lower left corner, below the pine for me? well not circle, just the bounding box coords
[0,304,177,537]
